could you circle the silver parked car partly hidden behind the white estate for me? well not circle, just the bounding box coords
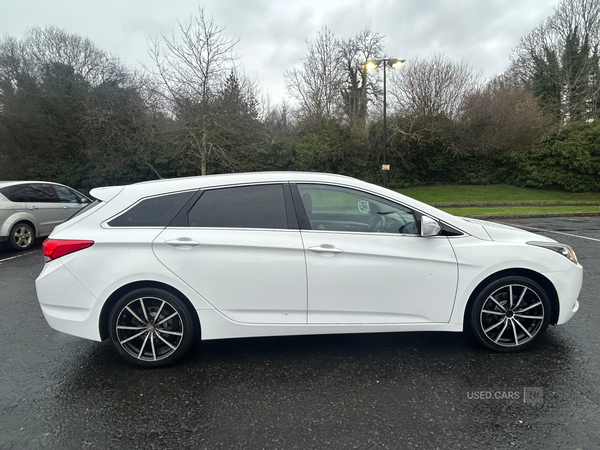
[0,181,91,250]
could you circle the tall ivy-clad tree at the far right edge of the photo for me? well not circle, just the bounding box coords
[510,0,600,125]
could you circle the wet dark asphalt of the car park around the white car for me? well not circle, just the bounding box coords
[0,217,600,450]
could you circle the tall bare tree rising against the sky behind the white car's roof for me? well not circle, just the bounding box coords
[150,8,238,175]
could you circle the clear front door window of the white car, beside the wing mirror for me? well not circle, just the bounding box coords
[298,184,419,234]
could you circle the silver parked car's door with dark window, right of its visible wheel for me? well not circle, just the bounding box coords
[22,183,64,236]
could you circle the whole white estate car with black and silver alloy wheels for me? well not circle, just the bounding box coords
[36,172,582,367]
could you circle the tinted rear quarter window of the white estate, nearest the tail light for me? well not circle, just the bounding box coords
[108,192,195,227]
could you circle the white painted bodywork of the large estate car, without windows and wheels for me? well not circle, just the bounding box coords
[36,172,582,340]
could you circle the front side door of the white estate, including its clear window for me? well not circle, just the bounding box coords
[295,184,458,324]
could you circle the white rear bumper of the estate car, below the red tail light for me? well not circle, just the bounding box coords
[35,260,102,341]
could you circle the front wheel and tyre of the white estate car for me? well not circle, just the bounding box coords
[469,276,551,352]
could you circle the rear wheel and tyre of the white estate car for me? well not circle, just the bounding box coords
[109,288,195,367]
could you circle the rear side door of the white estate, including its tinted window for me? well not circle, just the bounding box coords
[153,184,307,323]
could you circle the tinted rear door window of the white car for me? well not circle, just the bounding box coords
[188,184,288,228]
